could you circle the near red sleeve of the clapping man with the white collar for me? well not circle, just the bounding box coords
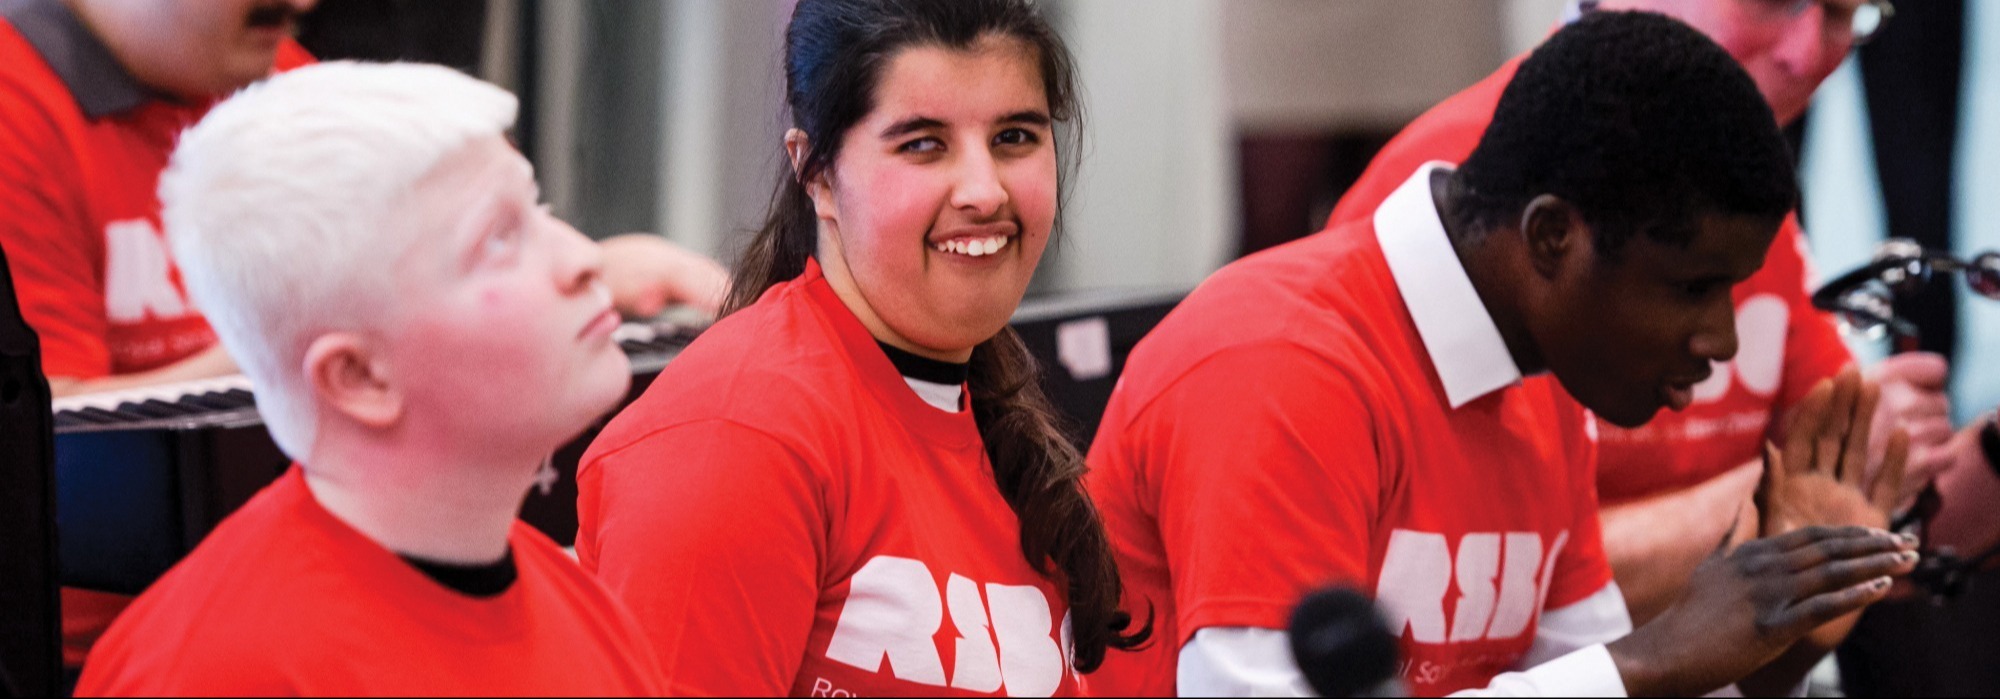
[1128,346,1382,645]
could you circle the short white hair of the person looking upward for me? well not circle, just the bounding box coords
[160,62,518,461]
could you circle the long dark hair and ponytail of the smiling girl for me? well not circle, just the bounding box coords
[722,0,1152,673]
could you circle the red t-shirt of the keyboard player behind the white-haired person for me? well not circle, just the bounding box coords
[0,13,312,379]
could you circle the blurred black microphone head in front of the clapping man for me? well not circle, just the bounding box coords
[1290,587,1404,697]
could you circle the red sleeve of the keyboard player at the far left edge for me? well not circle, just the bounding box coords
[0,76,112,379]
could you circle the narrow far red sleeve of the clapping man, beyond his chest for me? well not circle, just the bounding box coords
[1542,395,1612,609]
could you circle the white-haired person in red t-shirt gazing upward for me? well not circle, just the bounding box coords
[78,64,662,695]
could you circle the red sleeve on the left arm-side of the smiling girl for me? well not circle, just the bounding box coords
[578,419,826,697]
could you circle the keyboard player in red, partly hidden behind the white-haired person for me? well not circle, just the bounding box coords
[0,0,728,683]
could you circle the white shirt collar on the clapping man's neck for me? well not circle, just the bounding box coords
[1374,162,1522,409]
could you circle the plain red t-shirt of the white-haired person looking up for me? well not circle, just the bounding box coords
[76,467,662,697]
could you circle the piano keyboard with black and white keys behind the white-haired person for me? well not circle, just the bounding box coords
[54,324,698,595]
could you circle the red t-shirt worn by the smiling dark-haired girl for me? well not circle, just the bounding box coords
[576,264,1078,697]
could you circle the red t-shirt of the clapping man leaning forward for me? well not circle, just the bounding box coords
[1088,170,1610,695]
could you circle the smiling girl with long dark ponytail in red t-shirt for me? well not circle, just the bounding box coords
[578,0,1148,695]
